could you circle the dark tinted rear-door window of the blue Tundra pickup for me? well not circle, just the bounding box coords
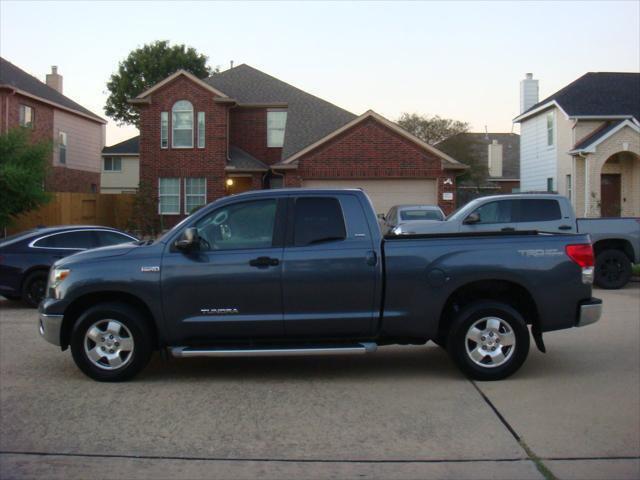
[294,197,346,247]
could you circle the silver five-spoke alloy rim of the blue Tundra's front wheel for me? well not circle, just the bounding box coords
[84,319,133,370]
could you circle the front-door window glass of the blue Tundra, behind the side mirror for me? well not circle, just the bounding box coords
[195,199,277,250]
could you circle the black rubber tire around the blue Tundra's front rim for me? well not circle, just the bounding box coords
[71,302,153,382]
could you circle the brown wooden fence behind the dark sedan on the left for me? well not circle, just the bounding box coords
[5,192,135,236]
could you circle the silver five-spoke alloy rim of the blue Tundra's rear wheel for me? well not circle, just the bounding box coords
[465,317,516,368]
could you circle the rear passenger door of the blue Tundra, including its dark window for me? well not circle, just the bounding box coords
[283,194,381,339]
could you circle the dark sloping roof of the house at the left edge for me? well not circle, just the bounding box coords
[0,57,107,123]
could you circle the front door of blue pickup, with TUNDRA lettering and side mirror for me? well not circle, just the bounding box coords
[161,199,286,345]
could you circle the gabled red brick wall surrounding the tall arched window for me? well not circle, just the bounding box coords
[140,77,227,226]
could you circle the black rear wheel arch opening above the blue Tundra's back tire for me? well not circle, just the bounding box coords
[438,279,540,342]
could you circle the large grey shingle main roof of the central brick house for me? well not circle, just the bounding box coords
[204,64,356,159]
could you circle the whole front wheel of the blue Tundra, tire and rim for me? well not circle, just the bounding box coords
[71,303,152,382]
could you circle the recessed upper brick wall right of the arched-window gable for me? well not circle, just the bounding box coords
[229,108,282,165]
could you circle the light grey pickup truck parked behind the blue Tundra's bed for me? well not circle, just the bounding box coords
[392,193,640,289]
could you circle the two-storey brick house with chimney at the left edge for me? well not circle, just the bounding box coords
[0,57,106,192]
